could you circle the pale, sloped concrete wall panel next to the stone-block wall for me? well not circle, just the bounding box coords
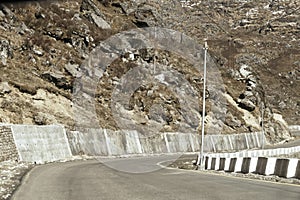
[10,125,72,163]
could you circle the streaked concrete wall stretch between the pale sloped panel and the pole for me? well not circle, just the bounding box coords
[68,129,199,156]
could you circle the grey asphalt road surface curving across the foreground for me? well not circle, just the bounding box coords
[12,156,300,200]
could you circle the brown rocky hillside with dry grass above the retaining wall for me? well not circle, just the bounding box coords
[0,0,300,142]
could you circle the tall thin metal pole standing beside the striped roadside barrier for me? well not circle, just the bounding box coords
[197,41,208,170]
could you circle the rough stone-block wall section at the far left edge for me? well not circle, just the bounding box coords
[0,126,19,162]
